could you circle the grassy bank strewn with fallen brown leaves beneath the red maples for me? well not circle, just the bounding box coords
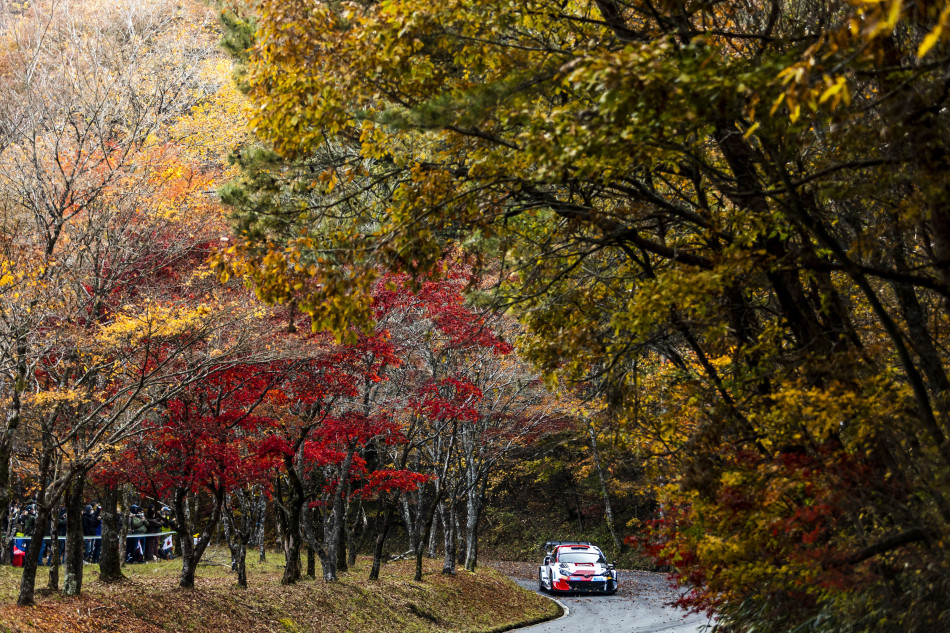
[0,551,560,633]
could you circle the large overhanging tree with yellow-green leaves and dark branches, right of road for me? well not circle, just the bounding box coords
[233,0,950,631]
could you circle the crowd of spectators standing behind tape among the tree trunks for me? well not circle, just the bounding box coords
[0,502,175,565]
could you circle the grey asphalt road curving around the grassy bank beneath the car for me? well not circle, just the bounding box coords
[512,571,712,633]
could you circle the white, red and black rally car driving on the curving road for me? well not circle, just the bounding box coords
[538,541,620,594]
